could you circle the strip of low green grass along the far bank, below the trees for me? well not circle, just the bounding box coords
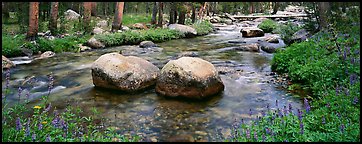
[2,19,212,57]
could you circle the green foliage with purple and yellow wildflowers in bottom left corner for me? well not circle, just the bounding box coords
[2,73,139,142]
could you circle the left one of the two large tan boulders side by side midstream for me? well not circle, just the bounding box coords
[91,53,160,92]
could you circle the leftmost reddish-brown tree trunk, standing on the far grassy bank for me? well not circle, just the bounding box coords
[26,2,39,41]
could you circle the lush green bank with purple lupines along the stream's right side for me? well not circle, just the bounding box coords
[226,10,360,142]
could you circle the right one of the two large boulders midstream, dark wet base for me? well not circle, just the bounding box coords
[156,57,224,99]
